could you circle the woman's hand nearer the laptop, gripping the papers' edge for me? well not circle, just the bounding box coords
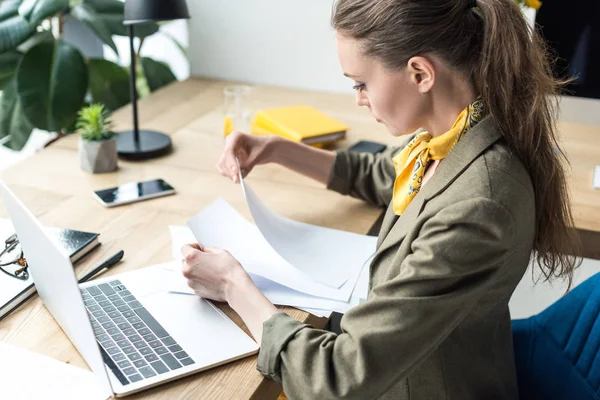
[181,244,249,302]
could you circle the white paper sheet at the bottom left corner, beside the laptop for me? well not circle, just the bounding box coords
[0,342,112,400]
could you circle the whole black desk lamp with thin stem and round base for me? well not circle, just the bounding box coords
[117,0,190,160]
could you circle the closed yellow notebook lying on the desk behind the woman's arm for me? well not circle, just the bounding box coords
[252,106,348,144]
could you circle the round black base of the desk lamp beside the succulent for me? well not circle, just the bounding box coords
[117,130,172,160]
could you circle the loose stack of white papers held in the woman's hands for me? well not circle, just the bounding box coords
[169,177,376,316]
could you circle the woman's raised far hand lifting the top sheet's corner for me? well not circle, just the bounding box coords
[217,131,277,183]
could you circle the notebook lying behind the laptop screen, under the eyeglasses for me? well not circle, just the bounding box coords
[0,219,100,320]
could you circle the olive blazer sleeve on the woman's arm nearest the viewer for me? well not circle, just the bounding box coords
[258,198,517,399]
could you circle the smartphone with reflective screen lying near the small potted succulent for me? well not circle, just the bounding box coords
[94,179,175,207]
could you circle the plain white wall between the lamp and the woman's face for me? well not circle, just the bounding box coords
[187,0,352,92]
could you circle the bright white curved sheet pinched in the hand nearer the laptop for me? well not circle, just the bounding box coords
[188,198,377,302]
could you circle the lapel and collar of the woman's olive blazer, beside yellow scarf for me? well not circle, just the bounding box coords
[371,116,502,265]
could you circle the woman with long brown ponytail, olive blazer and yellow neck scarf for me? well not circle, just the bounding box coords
[182,0,575,400]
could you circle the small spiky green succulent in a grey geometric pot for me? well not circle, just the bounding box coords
[76,104,117,174]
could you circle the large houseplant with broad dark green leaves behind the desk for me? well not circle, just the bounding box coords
[0,0,176,150]
